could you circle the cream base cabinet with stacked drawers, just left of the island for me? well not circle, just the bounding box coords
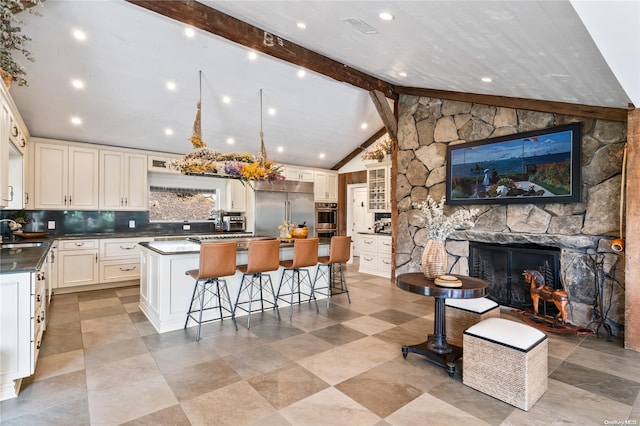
[100,237,153,284]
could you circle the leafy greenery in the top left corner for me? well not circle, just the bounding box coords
[0,0,41,86]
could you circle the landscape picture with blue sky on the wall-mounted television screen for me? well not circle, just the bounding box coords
[450,130,573,200]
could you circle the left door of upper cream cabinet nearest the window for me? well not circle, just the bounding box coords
[99,151,124,210]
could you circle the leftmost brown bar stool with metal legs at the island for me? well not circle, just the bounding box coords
[184,241,238,341]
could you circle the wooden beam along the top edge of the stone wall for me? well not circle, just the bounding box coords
[395,86,629,122]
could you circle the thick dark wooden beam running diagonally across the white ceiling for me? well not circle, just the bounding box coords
[127,0,398,99]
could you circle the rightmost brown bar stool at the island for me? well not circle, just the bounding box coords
[312,236,351,309]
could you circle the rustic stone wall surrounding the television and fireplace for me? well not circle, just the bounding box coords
[396,95,626,334]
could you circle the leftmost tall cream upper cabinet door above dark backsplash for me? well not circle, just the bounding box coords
[34,143,69,210]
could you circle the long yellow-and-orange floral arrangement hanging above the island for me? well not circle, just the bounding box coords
[169,148,284,181]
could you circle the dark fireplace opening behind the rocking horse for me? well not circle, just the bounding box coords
[469,242,562,315]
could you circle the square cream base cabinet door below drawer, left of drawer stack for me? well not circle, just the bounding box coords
[58,250,98,288]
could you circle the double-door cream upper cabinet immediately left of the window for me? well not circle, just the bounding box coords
[99,150,149,210]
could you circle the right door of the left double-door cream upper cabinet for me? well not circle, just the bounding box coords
[68,146,100,210]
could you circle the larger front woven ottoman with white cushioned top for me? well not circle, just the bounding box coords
[462,318,548,411]
